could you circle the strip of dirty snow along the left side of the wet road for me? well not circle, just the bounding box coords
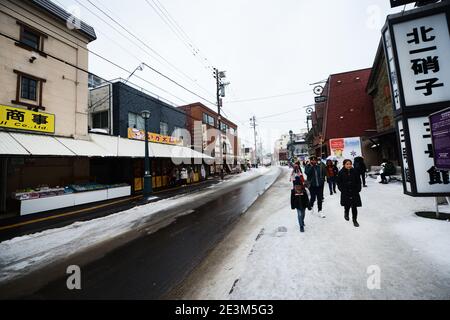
[0,168,279,285]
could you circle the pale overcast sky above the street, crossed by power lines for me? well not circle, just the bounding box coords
[53,0,412,152]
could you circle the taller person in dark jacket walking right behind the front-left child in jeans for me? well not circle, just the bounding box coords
[305,157,327,218]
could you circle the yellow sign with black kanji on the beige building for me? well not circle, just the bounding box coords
[0,105,55,133]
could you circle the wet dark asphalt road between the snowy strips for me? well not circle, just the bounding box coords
[24,170,281,299]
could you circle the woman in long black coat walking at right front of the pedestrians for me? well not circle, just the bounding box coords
[337,160,362,227]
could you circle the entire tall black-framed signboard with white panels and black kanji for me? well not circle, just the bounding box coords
[382,1,450,197]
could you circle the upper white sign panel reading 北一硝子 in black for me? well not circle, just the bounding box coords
[391,13,450,108]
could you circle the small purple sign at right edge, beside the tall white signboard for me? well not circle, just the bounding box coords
[429,108,450,171]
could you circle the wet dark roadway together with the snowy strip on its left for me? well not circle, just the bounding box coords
[0,168,281,299]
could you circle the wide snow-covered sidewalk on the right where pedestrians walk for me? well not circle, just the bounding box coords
[172,170,450,300]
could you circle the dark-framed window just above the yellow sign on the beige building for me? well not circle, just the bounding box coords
[11,70,46,110]
